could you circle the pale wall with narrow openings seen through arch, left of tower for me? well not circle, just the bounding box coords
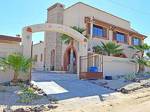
[32,42,45,70]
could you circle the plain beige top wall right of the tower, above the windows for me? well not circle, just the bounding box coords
[63,2,130,29]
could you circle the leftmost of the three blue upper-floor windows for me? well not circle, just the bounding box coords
[93,25,107,37]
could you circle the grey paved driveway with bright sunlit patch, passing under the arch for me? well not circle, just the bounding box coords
[32,72,113,100]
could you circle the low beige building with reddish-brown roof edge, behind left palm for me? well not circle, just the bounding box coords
[0,35,21,82]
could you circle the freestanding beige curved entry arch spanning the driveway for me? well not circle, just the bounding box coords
[22,23,88,74]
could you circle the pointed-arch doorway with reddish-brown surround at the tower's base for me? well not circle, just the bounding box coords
[63,45,77,73]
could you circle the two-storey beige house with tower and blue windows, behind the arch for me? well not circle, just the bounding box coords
[33,2,145,72]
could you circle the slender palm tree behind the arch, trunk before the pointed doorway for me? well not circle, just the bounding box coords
[61,26,85,72]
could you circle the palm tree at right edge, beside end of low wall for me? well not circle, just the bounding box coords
[129,44,150,74]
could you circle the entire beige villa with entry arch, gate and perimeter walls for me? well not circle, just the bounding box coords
[0,2,149,82]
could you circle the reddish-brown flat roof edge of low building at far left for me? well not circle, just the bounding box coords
[0,35,21,42]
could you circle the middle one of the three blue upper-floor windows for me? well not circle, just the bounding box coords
[114,32,127,43]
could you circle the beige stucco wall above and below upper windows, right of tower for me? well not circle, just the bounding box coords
[63,3,134,58]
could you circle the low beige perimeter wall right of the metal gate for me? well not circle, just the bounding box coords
[103,56,138,76]
